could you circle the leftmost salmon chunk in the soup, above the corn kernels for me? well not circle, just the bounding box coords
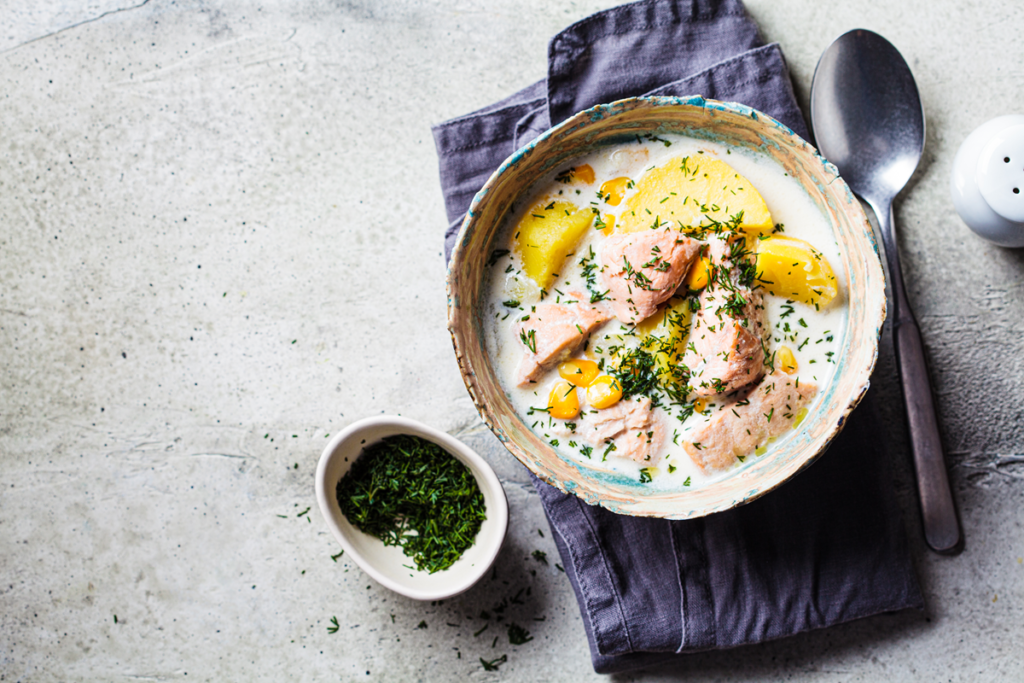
[515,292,611,386]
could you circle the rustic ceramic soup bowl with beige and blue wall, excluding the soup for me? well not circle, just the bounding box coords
[447,97,886,519]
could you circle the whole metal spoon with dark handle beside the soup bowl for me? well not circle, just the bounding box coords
[811,29,962,553]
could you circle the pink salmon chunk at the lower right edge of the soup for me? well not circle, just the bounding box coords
[682,371,818,474]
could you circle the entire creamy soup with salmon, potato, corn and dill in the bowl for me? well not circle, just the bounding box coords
[483,136,846,489]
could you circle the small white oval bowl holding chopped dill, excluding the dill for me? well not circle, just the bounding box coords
[316,416,509,600]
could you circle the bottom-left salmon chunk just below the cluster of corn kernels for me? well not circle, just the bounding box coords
[578,397,665,465]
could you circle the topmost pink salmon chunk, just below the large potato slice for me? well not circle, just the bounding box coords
[600,227,700,325]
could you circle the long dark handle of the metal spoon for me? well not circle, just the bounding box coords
[876,203,962,553]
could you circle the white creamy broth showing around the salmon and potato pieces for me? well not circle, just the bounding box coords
[483,135,846,489]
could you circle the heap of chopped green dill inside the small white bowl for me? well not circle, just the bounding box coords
[336,434,486,573]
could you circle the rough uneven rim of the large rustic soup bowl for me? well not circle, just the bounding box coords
[445,95,886,519]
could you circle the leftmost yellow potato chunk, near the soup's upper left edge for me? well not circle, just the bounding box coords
[516,202,594,290]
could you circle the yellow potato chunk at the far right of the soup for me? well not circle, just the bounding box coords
[757,236,839,306]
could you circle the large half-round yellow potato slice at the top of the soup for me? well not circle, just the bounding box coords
[617,155,773,234]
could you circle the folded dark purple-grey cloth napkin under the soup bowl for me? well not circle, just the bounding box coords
[433,0,923,673]
